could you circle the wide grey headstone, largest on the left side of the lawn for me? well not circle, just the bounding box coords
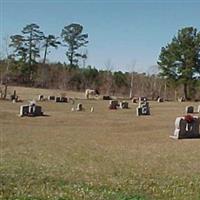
[19,103,43,117]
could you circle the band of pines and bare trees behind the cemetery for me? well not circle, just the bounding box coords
[0,23,200,100]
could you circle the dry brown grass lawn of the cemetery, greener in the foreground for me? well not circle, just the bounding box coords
[0,87,200,200]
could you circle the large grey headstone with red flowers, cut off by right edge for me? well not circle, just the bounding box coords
[170,115,200,139]
